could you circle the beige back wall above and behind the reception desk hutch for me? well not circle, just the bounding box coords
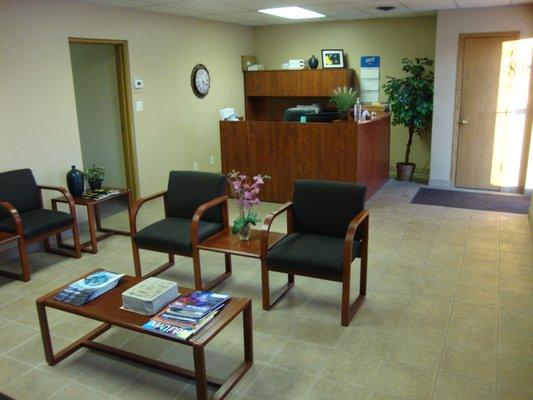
[254,17,436,173]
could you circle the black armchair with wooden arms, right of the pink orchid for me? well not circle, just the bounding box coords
[261,180,368,326]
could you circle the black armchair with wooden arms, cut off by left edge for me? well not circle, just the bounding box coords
[0,169,81,281]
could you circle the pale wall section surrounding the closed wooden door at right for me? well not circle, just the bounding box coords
[430,4,533,186]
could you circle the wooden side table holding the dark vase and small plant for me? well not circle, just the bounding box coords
[51,189,132,254]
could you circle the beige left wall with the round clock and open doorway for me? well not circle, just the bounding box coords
[0,0,252,194]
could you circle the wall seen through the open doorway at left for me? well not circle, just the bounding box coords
[70,43,126,187]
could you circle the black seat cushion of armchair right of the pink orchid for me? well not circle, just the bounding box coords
[266,233,361,276]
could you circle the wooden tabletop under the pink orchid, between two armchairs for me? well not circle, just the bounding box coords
[197,228,285,258]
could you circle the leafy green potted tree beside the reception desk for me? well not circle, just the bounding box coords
[383,58,433,181]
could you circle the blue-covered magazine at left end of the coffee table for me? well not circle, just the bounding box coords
[54,271,124,306]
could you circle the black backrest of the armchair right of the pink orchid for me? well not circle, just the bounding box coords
[292,179,366,240]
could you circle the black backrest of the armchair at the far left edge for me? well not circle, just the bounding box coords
[0,169,42,220]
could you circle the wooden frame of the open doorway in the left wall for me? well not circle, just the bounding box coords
[68,37,139,200]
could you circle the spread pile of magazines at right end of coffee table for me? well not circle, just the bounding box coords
[143,292,230,339]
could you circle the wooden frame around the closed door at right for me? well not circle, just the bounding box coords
[450,31,520,187]
